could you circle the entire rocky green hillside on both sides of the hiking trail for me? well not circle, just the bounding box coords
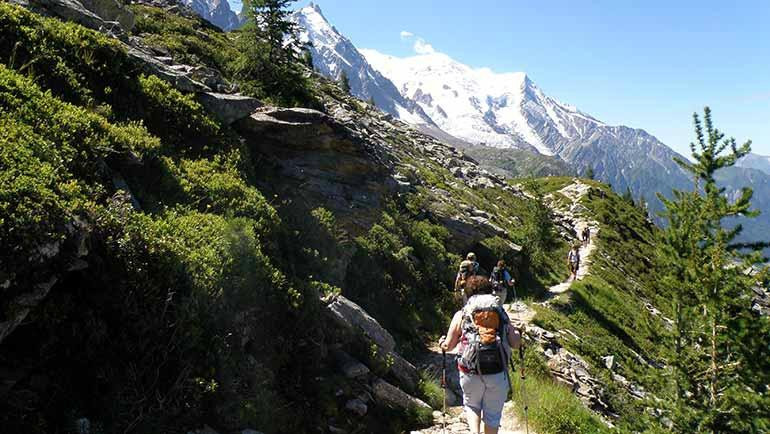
[0,0,768,433]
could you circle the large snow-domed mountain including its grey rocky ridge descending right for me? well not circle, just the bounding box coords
[361,50,689,199]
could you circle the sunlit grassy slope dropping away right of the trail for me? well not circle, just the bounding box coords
[534,179,672,431]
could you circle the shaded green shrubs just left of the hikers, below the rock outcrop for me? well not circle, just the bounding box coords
[343,209,454,350]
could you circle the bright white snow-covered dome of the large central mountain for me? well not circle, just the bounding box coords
[361,49,600,155]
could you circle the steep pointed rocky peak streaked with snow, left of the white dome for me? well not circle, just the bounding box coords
[293,2,433,126]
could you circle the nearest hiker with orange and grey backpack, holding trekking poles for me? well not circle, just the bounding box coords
[439,276,521,434]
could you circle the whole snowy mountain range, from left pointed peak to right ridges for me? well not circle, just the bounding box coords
[295,3,770,244]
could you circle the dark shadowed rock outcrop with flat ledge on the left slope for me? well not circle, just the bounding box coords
[234,108,397,233]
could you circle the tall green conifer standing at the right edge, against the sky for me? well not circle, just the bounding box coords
[658,108,770,433]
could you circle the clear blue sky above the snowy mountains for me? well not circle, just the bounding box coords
[237,0,770,156]
